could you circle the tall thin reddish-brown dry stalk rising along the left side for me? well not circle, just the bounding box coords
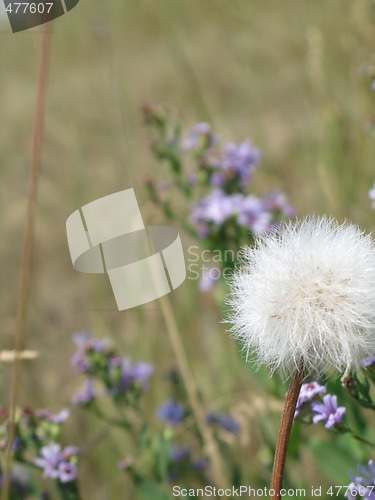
[1,23,51,500]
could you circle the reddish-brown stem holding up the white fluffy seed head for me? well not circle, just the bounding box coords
[271,368,304,500]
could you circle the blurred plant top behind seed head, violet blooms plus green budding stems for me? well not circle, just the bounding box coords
[143,106,295,291]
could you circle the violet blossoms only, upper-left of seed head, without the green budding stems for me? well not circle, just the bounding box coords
[184,123,295,238]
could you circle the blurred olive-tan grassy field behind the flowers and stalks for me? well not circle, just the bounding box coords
[0,0,375,500]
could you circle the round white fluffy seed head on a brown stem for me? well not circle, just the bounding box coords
[228,217,375,376]
